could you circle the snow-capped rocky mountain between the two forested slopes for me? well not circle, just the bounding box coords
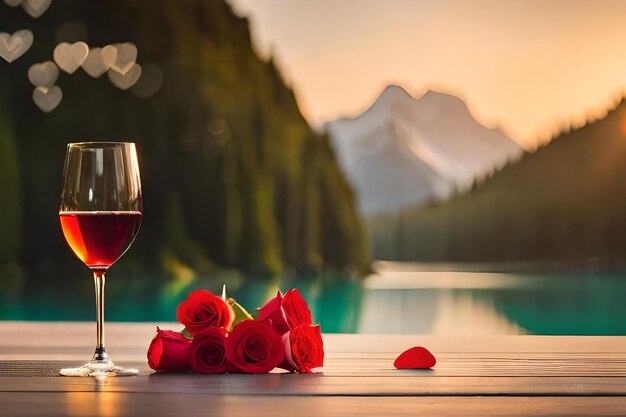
[327,86,524,215]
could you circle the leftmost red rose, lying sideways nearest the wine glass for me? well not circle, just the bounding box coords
[148,327,191,372]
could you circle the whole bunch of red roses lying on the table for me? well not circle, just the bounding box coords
[148,289,324,374]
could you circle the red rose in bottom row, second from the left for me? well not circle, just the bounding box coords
[189,326,228,374]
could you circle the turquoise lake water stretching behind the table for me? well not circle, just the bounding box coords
[0,263,626,335]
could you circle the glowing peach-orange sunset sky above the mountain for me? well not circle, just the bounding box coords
[230,0,626,148]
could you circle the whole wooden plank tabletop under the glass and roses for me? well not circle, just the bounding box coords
[0,322,626,417]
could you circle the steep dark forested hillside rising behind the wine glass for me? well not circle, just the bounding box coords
[0,0,367,286]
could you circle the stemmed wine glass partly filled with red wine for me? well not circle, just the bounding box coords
[59,142,143,376]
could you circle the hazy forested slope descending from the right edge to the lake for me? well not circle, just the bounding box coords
[370,101,626,266]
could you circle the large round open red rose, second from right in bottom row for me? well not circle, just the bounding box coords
[226,320,285,374]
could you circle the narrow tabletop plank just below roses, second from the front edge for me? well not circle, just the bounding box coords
[0,374,626,396]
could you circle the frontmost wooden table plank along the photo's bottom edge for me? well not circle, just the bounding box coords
[0,393,626,417]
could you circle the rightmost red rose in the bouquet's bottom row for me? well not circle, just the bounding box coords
[280,324,324,374]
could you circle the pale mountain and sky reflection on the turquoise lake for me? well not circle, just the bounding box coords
[358,262,525,335]
